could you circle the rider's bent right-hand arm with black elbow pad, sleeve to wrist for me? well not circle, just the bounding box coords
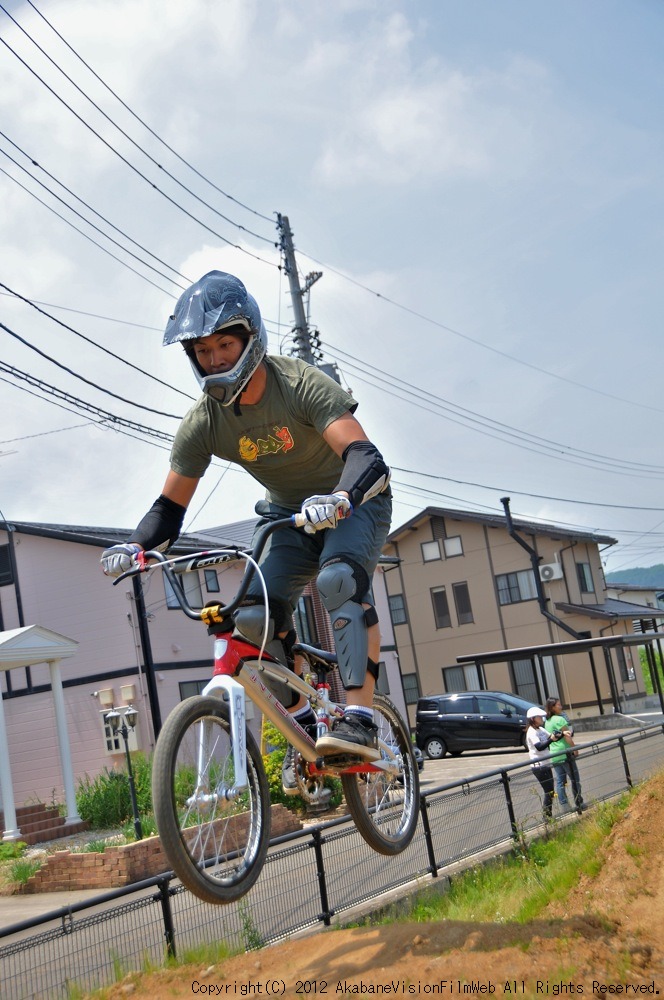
[323,413,390,507]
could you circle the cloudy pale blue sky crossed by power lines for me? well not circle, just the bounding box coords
[0,0,664,572]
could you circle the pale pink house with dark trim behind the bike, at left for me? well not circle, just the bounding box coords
[0,520,405,809]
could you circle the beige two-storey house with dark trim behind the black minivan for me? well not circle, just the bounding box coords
[385,503,660,725]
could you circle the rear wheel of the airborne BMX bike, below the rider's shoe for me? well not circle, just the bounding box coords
[341,694,420,855]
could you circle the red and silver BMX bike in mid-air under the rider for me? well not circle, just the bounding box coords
[118,514,419,903]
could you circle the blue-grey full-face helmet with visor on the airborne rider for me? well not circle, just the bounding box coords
[164,271,267,406]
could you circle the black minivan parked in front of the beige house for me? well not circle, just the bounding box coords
[415,691,533,760]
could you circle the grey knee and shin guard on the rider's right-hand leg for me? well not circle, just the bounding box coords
[316,561,375,690]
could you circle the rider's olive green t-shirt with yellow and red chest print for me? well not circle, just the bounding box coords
[171,356,357,510]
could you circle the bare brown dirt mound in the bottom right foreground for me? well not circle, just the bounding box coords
[101,774,664,1000]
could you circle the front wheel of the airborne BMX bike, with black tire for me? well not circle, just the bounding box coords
[152,695,270,904]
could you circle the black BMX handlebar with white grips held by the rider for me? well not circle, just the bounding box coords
[113,512,307,625]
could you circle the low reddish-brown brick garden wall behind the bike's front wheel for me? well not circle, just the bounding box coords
[19,805,302,893]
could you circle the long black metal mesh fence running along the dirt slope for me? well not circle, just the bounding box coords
[0,725,664,1000]
